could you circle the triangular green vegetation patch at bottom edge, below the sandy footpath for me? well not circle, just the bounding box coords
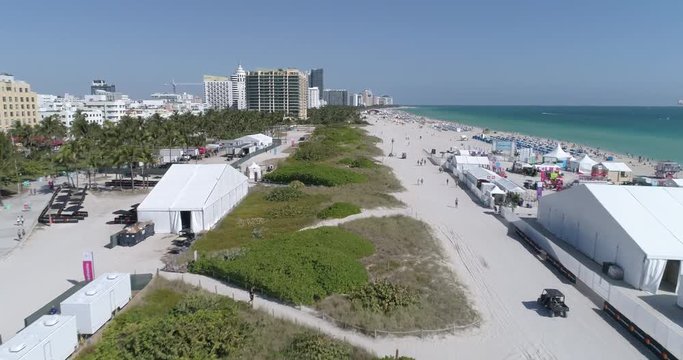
[77,278,374,360]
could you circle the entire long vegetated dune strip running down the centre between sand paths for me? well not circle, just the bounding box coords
[189,114,478,334]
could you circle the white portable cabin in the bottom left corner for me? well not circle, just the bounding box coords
[0,315,78,360]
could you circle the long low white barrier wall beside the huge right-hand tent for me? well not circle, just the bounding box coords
[501,208,683,359]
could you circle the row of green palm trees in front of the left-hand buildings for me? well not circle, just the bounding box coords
[0,109,285,191]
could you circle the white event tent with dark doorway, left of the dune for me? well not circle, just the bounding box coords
[137,164,249,234]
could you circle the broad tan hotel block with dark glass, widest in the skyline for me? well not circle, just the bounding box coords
[247,69,308,119]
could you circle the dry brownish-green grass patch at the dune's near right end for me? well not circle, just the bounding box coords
[316,216,478,331]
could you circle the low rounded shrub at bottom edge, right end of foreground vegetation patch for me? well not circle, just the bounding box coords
[284,334,351,360]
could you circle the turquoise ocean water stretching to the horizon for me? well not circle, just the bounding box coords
[405,106,683,163]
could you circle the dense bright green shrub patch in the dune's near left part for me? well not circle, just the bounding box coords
[191,227,374,304]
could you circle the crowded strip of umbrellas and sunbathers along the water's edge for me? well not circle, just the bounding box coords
[382,107,665,177]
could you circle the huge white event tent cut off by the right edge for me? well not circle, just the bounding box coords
[538,184,683,294]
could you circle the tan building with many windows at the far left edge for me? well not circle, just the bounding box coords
[0,73,40,131]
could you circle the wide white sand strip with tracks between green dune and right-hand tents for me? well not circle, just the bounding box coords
[358,116,649,359]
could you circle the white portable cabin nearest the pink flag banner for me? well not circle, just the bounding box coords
[60,273,132,335]
